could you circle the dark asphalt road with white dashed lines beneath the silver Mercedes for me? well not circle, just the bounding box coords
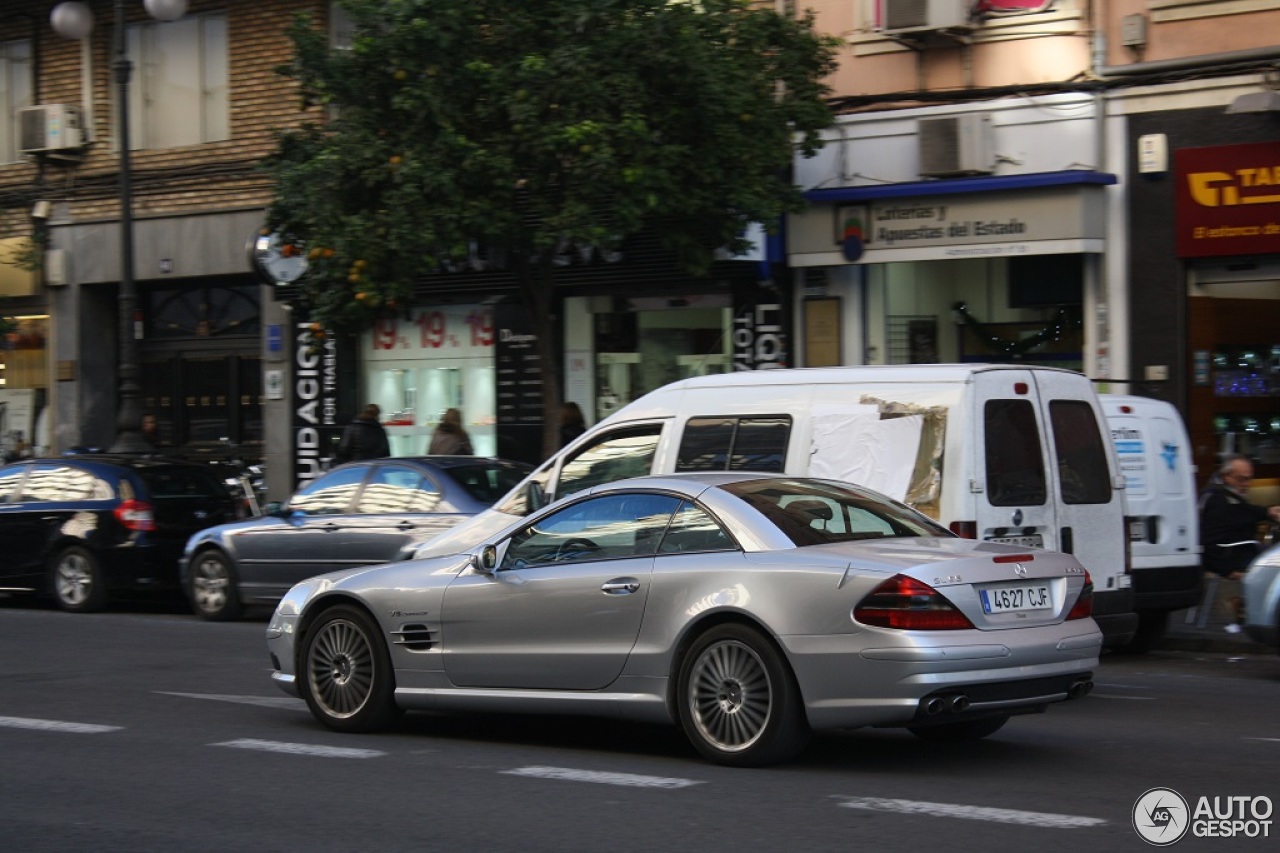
[0,601,1280,853]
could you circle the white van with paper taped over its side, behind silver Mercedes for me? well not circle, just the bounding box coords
[417,365,1138,644]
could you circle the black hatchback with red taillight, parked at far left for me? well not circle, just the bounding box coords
[0,455,236,612]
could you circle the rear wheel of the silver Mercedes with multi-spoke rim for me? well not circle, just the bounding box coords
[676,625,809,767]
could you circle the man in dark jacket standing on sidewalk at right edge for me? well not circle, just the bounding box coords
[1199,455,1280,633]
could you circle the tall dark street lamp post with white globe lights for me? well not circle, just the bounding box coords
[49,0,187,453]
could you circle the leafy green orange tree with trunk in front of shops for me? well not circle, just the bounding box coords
[265,0,838,452]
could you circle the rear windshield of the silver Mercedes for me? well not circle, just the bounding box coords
[721,479,951,546]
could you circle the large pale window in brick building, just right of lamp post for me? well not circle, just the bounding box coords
[127,14,230,149]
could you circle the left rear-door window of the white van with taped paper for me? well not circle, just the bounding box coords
[983,400,1048,506]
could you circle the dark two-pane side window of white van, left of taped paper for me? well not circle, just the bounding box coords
[676,415,791,471]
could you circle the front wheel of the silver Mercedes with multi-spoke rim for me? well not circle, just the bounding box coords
[298,605,403,731]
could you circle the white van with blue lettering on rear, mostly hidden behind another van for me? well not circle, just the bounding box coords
[1098,394,1204,652]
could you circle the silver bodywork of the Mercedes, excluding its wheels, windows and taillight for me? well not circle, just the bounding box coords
[268,474,1102,729]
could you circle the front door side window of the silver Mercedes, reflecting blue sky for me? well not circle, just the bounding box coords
[500,493,680,569]
